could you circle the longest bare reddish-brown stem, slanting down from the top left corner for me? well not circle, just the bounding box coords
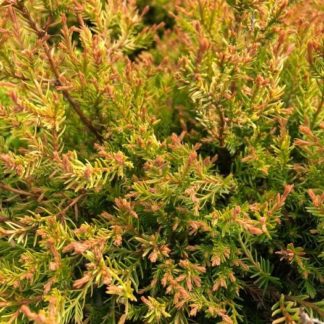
[15,2,103,142]
